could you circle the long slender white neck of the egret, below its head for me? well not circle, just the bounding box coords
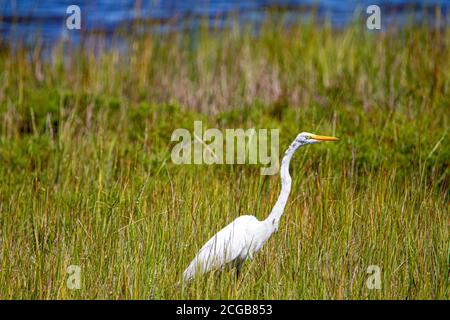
[264,142,299,232]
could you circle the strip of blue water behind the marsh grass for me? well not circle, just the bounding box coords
[0,0,450,43]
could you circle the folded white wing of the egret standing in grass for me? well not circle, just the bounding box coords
[185,216,256,278]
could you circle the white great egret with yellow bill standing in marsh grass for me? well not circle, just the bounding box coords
[183,132,338,282]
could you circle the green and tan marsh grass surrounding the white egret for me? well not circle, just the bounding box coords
[0,19,450,299]
